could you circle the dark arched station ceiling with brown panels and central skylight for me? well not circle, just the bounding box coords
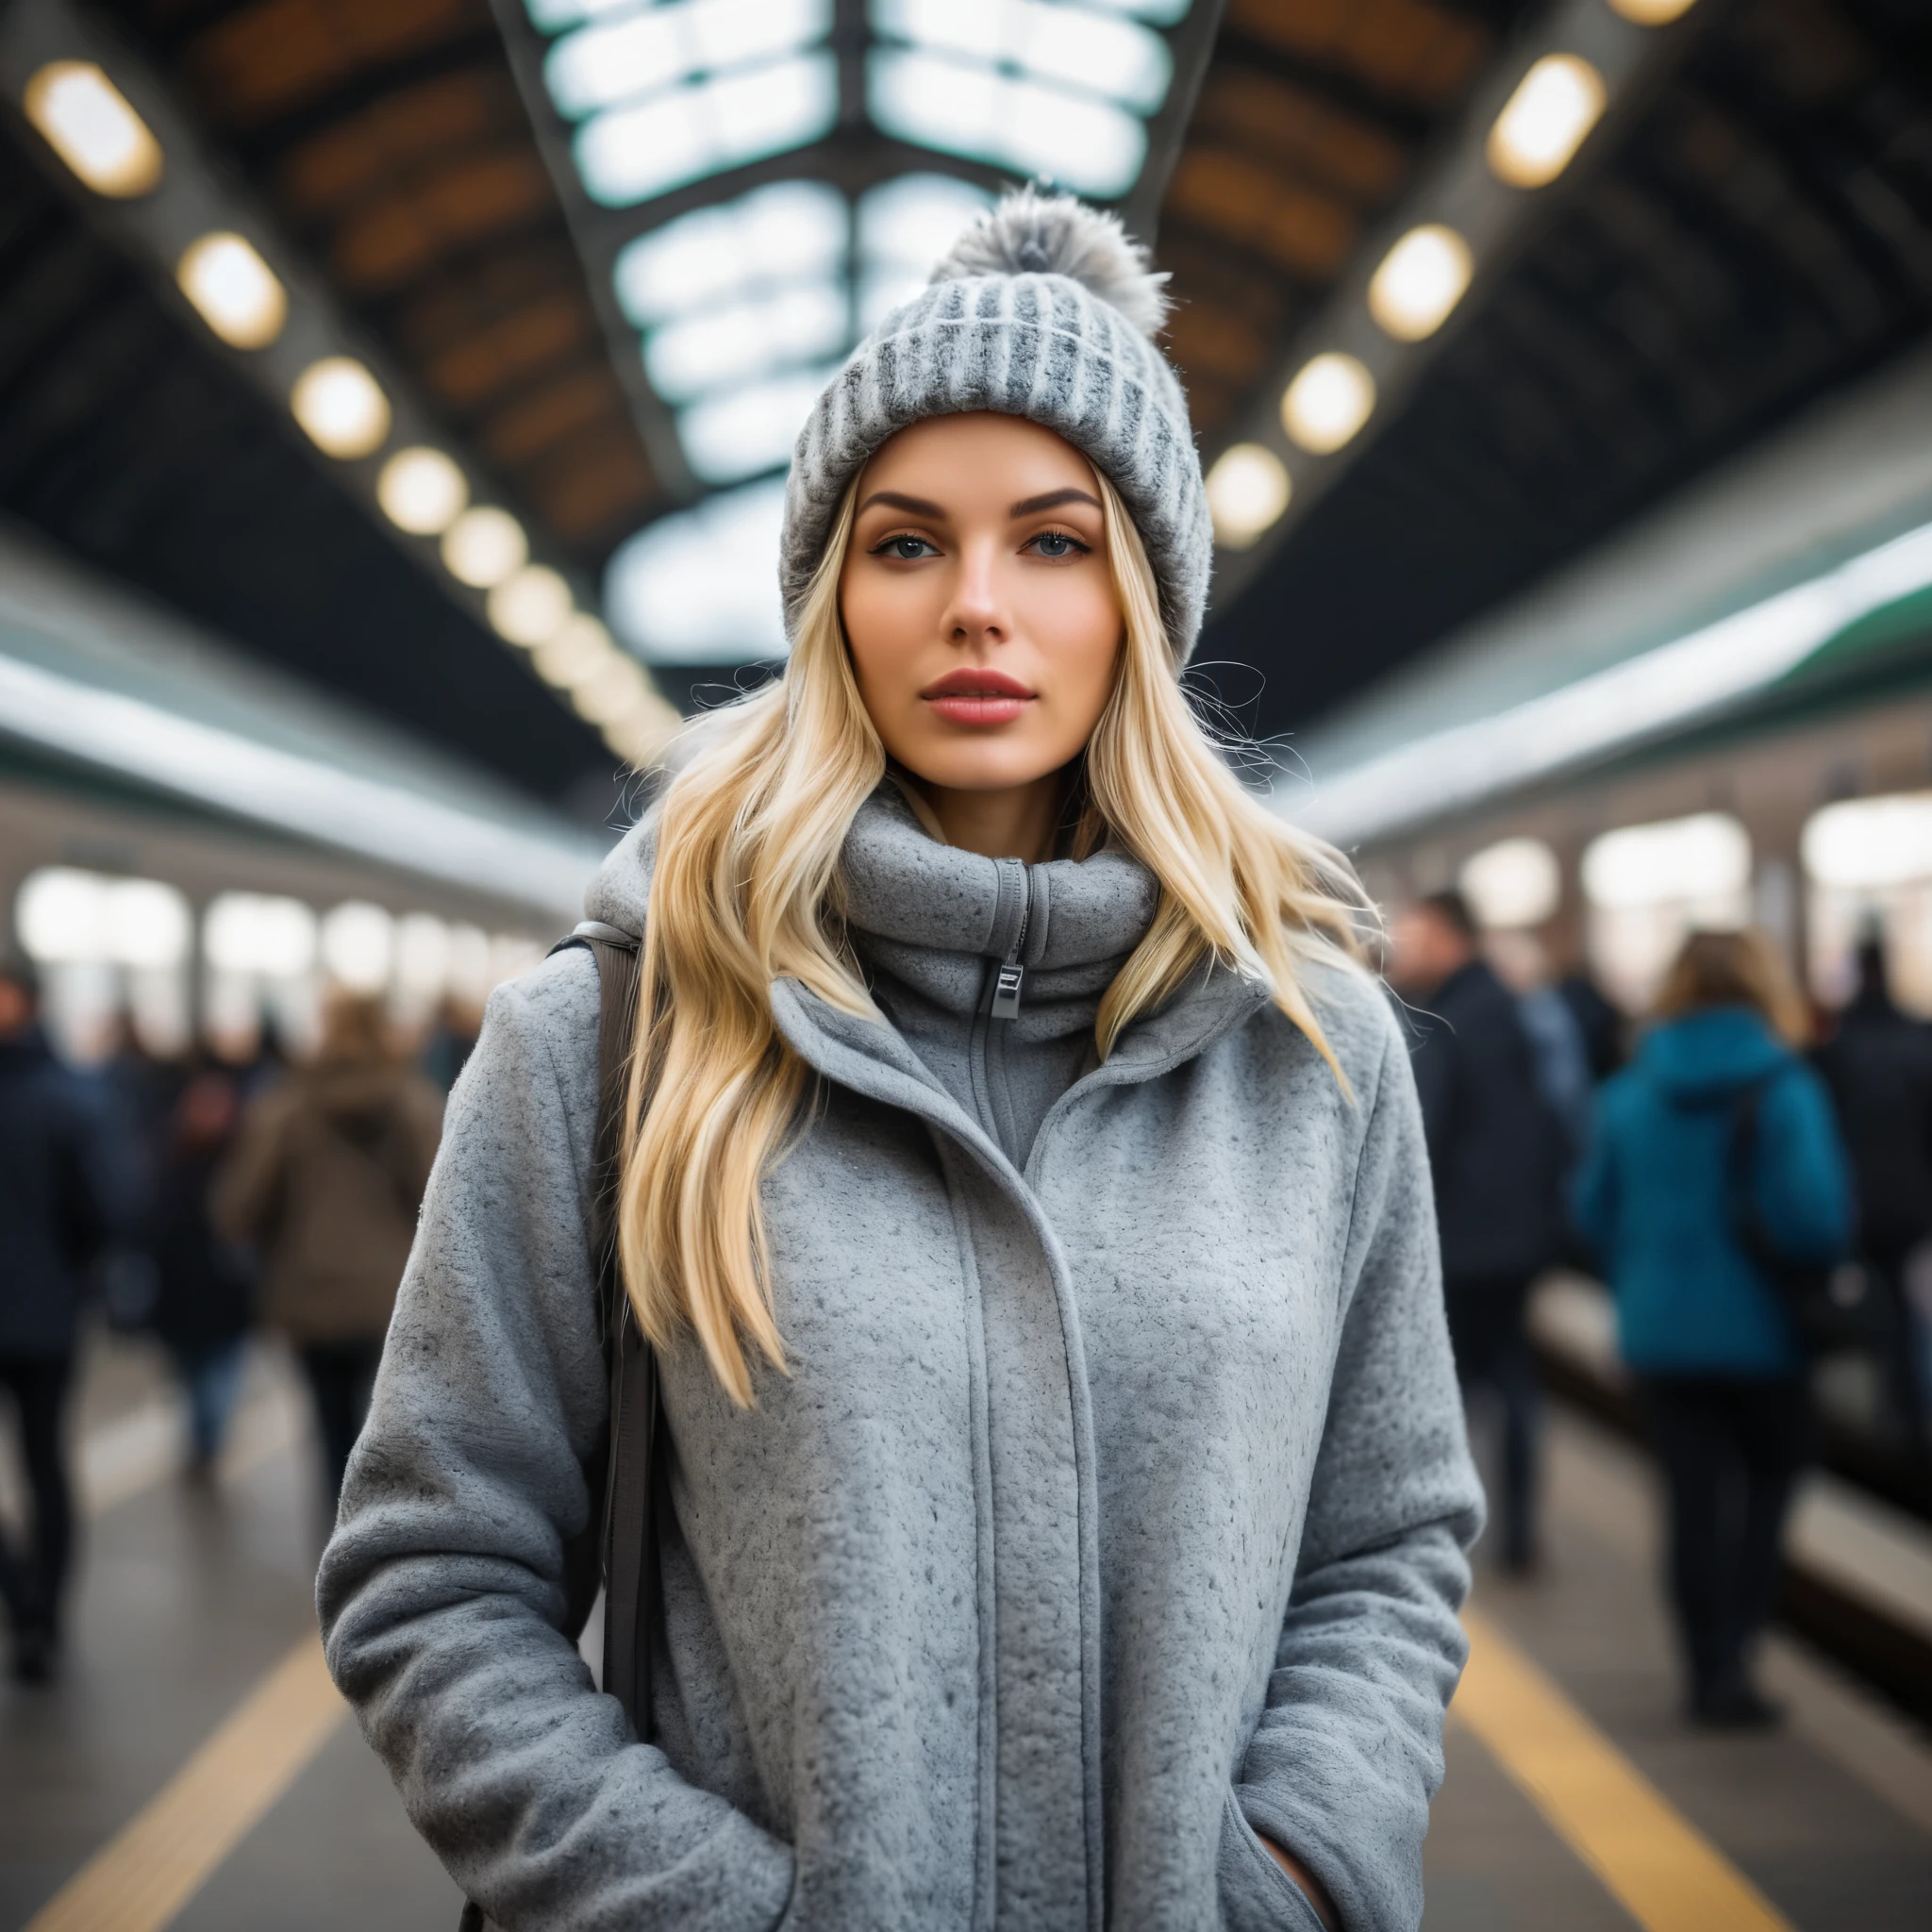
[0,0,1932,798]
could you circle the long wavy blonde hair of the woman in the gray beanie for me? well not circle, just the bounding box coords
[618,475,1368,1407]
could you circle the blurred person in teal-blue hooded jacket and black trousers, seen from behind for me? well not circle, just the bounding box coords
[1576,933,1851,1725]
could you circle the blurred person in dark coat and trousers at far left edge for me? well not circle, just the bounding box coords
[0,960,114,1683]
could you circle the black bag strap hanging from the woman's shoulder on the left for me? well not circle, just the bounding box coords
[458,920,657,1932]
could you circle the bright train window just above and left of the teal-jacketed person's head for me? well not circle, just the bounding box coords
[1582,811,1750,1012]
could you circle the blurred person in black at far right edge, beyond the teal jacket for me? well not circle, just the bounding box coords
[1816,935,1932,1455]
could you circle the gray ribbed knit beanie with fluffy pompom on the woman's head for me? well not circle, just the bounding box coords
[778,188,1213,665]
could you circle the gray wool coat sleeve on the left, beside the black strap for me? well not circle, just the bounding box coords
[317,955,792,1932]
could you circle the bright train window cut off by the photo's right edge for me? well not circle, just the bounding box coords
[1799,792,1932,1014]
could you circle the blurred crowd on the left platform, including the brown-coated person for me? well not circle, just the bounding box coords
[0,958,456,1683]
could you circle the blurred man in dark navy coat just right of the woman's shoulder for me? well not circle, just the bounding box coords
[1390,892,1565,1571]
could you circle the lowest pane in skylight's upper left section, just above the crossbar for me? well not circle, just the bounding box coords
[575,54,839,208]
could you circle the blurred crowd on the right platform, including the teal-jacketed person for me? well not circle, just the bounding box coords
[1390,892,1932,1725]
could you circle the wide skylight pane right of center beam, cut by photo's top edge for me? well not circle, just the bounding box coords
[872,0,1173,114]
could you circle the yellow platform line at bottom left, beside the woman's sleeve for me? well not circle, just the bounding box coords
[27,1637,348,1932]
